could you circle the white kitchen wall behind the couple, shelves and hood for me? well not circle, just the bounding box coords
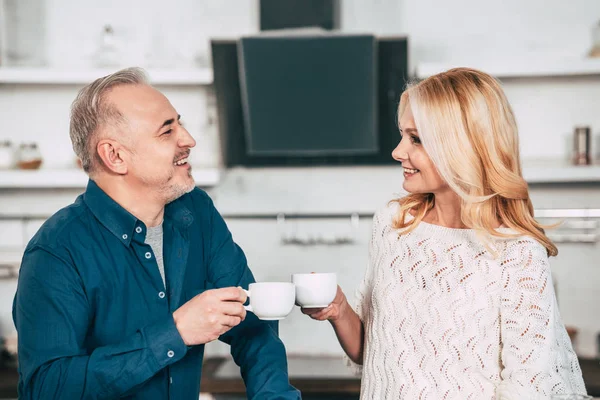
[0,0,600,355]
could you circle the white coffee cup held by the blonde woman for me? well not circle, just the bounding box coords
[292,273,337,308]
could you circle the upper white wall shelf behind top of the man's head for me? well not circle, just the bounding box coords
[0,67,213,86]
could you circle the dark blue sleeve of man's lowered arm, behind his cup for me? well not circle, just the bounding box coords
[208,201,301,400]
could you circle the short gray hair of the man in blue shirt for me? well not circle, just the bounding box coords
[69,67,149,174]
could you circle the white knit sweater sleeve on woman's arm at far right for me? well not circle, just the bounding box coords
[497,238,586,400]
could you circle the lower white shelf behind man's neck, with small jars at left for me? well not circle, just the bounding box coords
[0,167,221,189]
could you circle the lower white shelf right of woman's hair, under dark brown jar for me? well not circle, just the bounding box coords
[523,160,600,183]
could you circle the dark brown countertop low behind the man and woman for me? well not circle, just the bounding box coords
[0,355,600,399]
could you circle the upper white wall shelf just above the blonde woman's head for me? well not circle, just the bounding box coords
[416,58,600,78]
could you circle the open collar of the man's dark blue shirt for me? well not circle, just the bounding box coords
[83,179,194,246]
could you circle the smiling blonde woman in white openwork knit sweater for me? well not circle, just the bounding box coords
[303,68,585,399]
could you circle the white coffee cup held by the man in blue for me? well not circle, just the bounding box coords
[244,282,296,321]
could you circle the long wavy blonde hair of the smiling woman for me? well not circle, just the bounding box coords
[393,68,558,256]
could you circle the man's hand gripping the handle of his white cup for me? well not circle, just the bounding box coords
[173,287,246,346]
